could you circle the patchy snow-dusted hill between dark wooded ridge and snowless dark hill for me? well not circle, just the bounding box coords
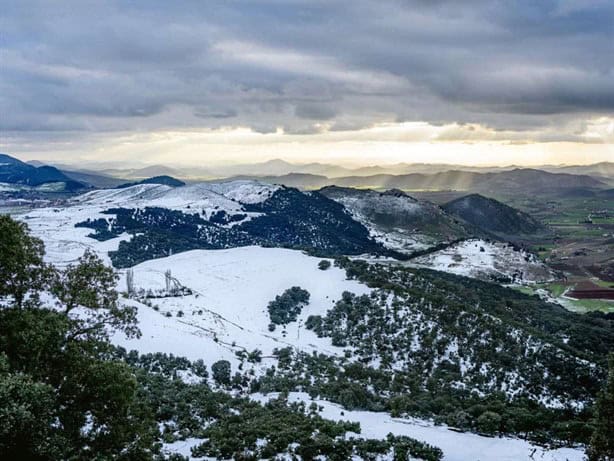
[319,186,473,252]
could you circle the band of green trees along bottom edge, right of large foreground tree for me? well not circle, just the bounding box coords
[117,350,442,461]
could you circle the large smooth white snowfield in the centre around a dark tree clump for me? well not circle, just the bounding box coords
[113,246,370,371]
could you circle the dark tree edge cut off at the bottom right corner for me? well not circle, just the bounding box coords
[587,353,614,461]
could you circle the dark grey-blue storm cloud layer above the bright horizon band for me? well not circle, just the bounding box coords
[0,0,614,139]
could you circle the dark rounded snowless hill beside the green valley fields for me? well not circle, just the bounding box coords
[442,194,548,236]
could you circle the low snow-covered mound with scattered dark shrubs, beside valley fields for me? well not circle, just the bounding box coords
[409,239,554,283]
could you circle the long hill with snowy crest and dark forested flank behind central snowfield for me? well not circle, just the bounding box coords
[26,181,395,267]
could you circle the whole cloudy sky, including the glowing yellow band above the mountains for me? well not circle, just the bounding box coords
[0,0,614,166]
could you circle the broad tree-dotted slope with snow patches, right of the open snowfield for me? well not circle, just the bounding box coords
[254,255,614,444]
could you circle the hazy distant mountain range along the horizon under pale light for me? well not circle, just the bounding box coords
[0,154,614,197]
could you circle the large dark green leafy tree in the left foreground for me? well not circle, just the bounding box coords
[0,217,157,460]
